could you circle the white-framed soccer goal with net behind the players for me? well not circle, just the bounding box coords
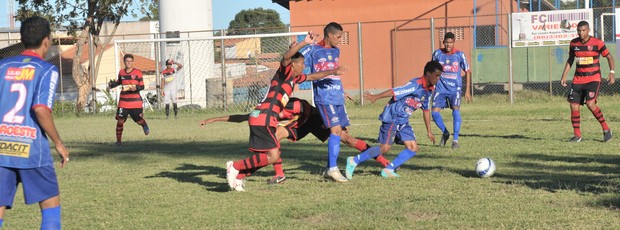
[114,33,304,111]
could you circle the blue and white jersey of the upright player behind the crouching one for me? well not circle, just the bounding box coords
[433,49,469,93]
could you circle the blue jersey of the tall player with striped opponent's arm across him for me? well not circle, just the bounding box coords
[300,41,344,105]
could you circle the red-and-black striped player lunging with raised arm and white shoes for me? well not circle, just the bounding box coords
[226,33,346,191]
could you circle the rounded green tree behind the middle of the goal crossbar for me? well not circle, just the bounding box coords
[226,7,288,53]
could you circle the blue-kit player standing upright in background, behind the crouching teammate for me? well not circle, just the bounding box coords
[431,32,471,149]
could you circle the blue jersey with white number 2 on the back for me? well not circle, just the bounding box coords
[0,51,59,168]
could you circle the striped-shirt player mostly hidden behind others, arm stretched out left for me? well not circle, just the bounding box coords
[200,97,390,184]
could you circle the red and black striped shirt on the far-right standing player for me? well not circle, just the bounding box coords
[568,37,609,84]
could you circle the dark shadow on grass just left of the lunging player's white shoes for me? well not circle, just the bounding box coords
[145,164,230,192]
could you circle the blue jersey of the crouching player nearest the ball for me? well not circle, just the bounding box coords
[379,77,433,125]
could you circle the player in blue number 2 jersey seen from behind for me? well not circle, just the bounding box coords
[0,16,69,229]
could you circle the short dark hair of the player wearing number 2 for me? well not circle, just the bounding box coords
[19,16,52,49]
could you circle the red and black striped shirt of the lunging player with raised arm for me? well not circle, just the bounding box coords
[248,64,306,127]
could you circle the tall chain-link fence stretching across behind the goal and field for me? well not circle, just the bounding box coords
[0,1,620,112]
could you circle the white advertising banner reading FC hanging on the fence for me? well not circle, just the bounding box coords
[511,9,592,47]
